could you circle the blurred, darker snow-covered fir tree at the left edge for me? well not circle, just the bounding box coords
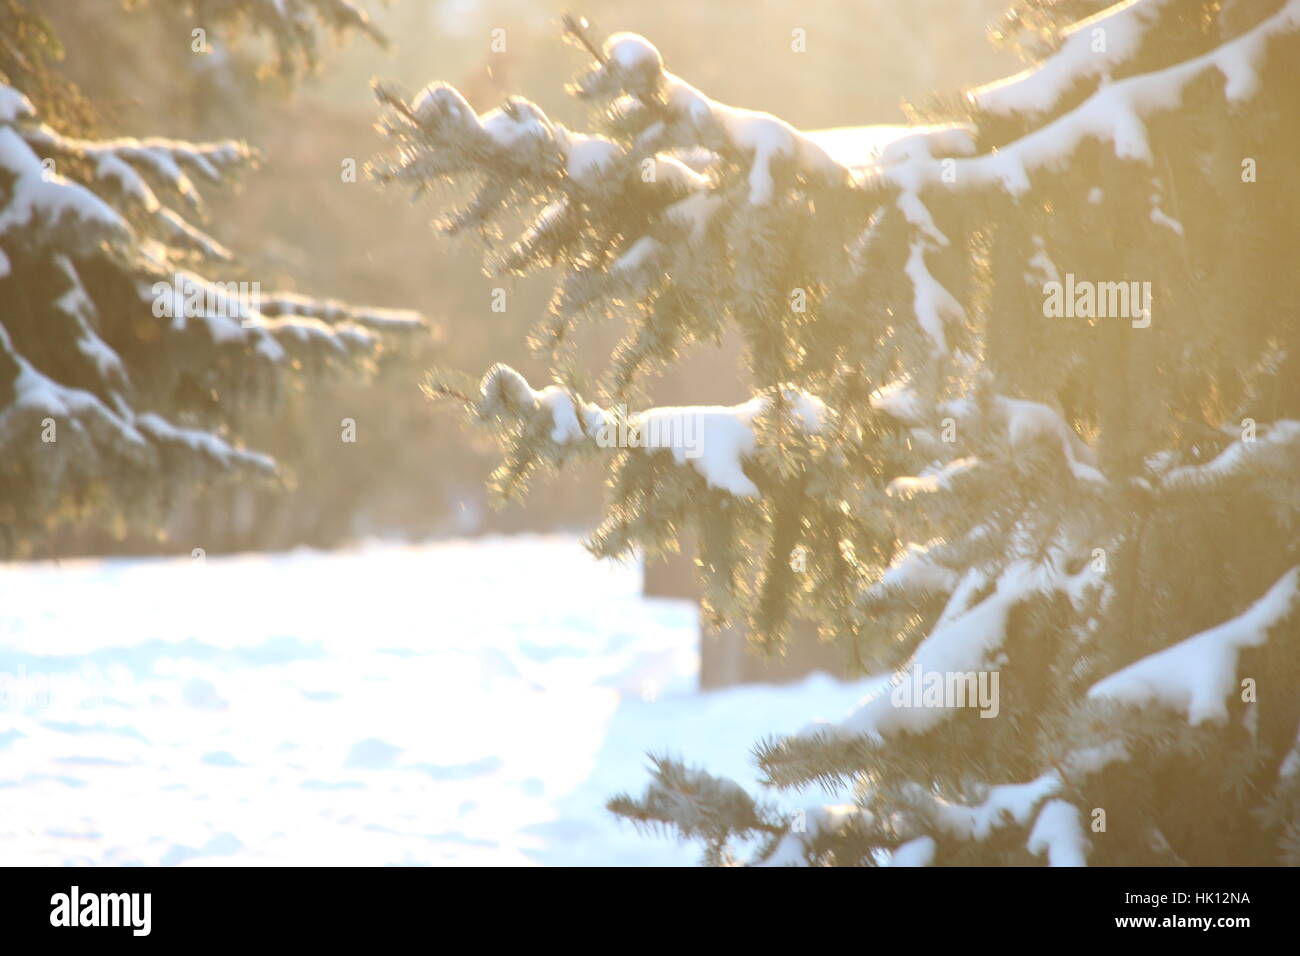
[0,0,421,555]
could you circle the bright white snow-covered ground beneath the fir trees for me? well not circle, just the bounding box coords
[0,537,867,865]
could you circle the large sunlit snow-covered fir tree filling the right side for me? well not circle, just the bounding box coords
[374,0,1300,865]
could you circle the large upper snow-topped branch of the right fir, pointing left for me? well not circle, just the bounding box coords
[372,27,974,377]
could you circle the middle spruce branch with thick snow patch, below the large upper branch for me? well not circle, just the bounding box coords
[449,365,879,650]
